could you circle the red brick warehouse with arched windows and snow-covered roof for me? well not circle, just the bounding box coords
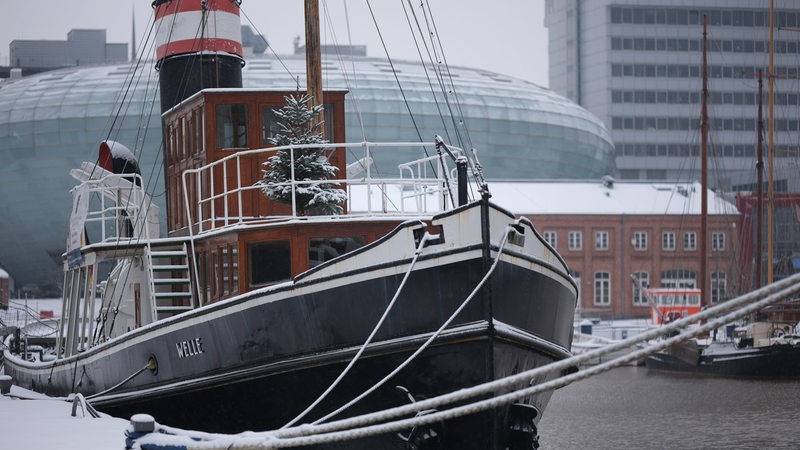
[490,178,748,319]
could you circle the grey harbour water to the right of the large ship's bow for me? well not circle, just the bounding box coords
[539,367,800,450]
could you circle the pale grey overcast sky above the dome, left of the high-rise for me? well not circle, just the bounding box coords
[0,0,547,86]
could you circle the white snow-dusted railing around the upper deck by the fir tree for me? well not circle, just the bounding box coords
[182,142,456,232]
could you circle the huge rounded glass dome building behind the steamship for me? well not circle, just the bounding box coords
[0,56,616,295]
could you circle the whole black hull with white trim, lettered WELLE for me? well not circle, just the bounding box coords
[1,202,575,450]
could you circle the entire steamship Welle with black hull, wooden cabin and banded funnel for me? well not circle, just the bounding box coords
[4,0,578,450]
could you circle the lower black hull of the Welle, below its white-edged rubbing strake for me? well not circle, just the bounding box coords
[108,336,564,449]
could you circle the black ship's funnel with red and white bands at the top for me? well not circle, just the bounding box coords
[153,0,244,113]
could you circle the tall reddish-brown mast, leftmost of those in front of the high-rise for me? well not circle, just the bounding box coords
[698,14,708,305]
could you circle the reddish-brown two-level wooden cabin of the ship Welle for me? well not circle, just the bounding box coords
[162,89,399,307]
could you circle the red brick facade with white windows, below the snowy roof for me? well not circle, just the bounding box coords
[523,214,740,318]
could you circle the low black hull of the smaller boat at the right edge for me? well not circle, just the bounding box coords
[645,345,800,378]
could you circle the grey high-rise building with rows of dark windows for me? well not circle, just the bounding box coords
[545,0,800,191]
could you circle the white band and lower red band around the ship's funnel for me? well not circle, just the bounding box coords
[155,11,242,60]
